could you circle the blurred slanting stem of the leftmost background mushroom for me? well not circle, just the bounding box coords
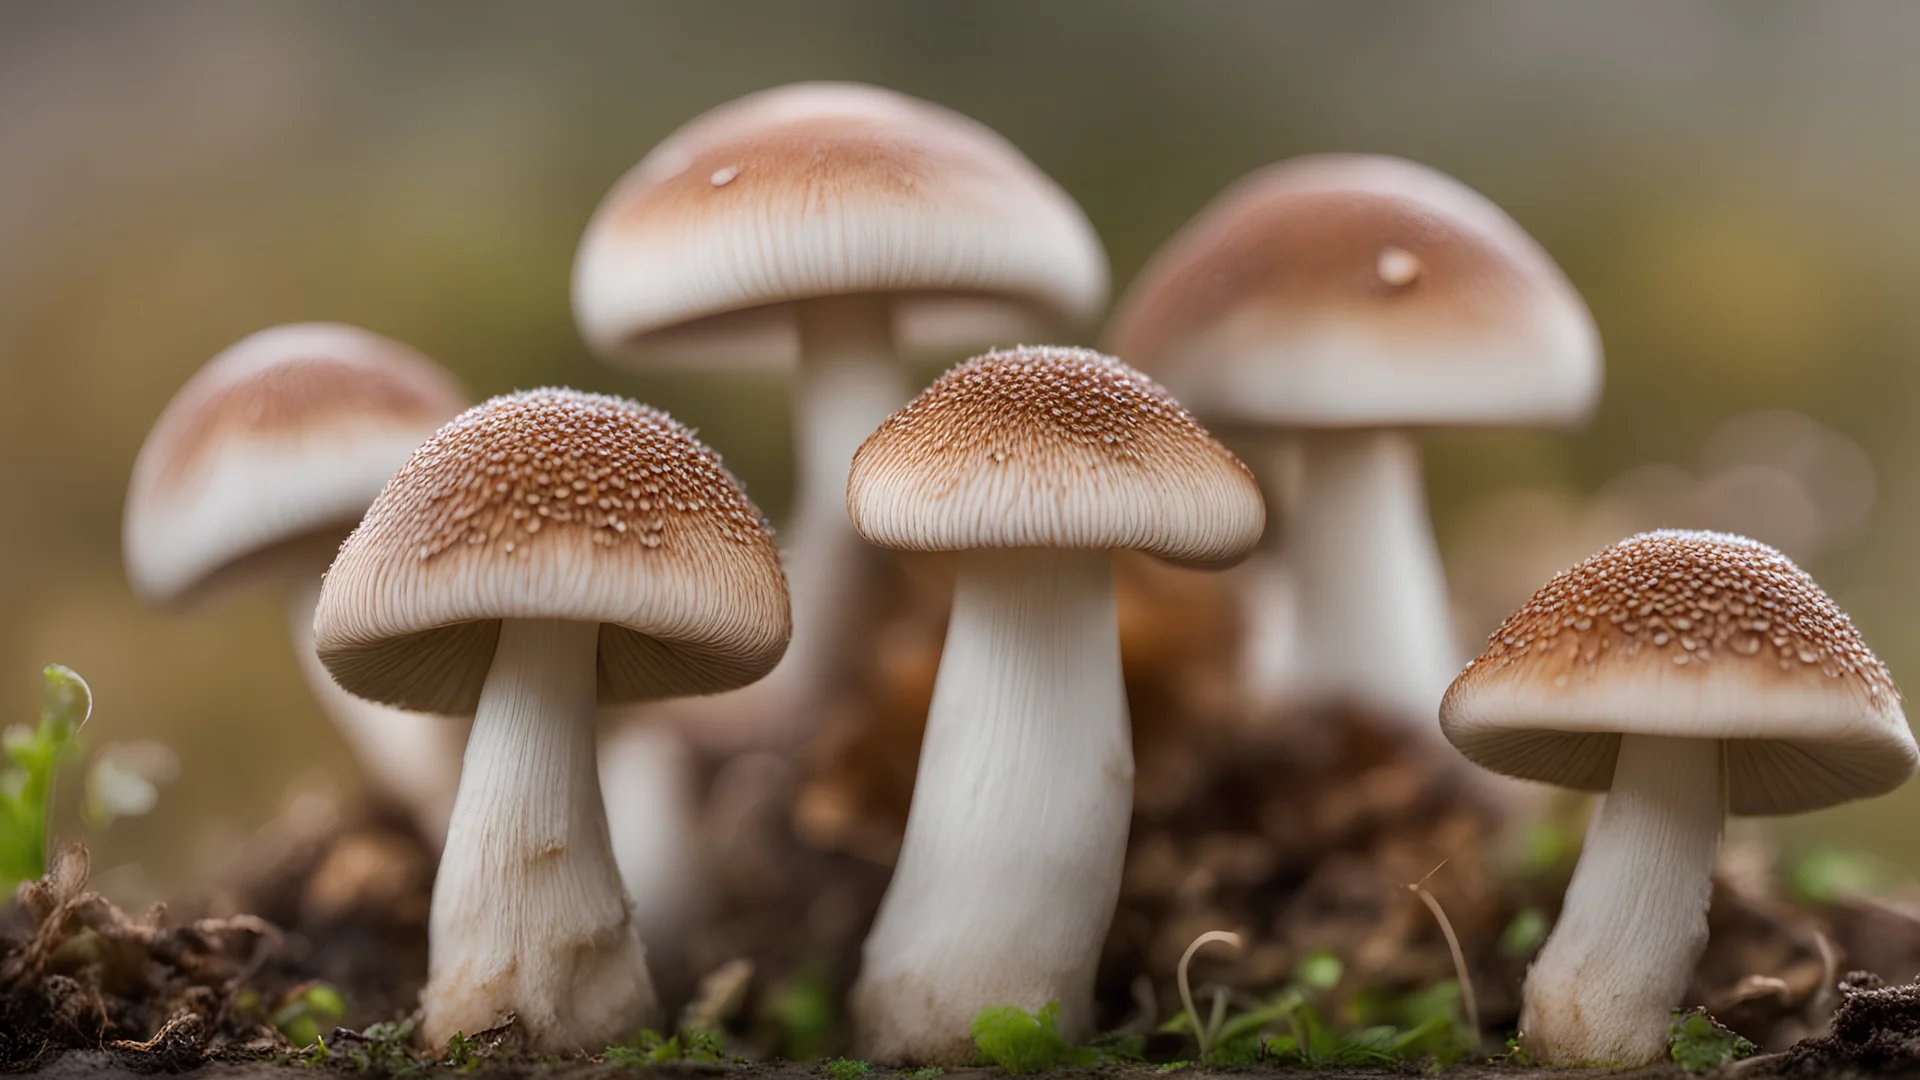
[284,573,467,851]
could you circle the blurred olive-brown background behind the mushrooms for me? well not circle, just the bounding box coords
[0,0,1920,896]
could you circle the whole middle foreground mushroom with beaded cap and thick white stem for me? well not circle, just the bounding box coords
[847,346,1265,1063]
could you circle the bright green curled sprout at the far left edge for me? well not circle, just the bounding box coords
[0,663,94,894]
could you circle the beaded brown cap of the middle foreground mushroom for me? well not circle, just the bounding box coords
[847,346,1267,567]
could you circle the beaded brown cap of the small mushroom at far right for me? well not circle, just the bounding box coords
[1440,530,1920,813]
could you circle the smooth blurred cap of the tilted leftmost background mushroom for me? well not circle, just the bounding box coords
[123,323,467,603]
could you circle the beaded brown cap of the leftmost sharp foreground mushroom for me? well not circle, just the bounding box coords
[313,388,791,715]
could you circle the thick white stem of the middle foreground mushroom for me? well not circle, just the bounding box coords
[851,550,1133,1065]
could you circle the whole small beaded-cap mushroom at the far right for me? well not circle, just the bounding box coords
[1440,532,1920,1067]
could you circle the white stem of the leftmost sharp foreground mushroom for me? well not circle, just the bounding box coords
[420,619,657,1053]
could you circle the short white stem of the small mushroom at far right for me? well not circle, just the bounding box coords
[1521,734,1726,1068]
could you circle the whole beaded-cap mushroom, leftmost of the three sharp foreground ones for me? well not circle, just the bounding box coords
[315,390,789,1053]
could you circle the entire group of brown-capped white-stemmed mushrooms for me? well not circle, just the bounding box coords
[125,83,1920,1067]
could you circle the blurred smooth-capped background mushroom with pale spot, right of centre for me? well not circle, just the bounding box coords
[1110,156,1601,730]
